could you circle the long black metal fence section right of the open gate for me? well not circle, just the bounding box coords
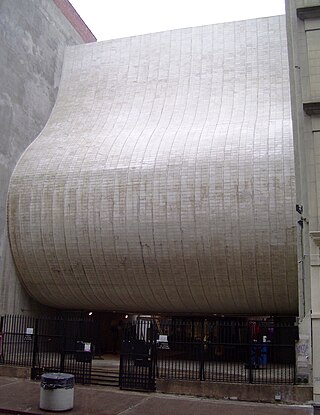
[156,319,297,384]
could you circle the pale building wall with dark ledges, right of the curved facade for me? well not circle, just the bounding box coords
[286,0,320,402]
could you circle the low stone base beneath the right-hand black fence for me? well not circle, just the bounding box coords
[157,379,313,404]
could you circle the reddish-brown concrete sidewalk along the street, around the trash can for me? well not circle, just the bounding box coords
[0,377,313,415]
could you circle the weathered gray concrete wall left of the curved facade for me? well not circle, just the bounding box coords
[0,0,92,314]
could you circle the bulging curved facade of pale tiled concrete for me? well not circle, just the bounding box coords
[8,17,297,314]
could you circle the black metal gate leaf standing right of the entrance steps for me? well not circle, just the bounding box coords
[120,320,156,391]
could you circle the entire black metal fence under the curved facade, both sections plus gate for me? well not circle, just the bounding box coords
[0,316,297,391]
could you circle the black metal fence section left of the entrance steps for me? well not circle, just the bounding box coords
[0,315,93,384]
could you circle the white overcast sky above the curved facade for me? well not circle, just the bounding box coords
[70,0,285,40]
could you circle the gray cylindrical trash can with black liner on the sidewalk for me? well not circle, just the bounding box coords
[40,373,74,411]
